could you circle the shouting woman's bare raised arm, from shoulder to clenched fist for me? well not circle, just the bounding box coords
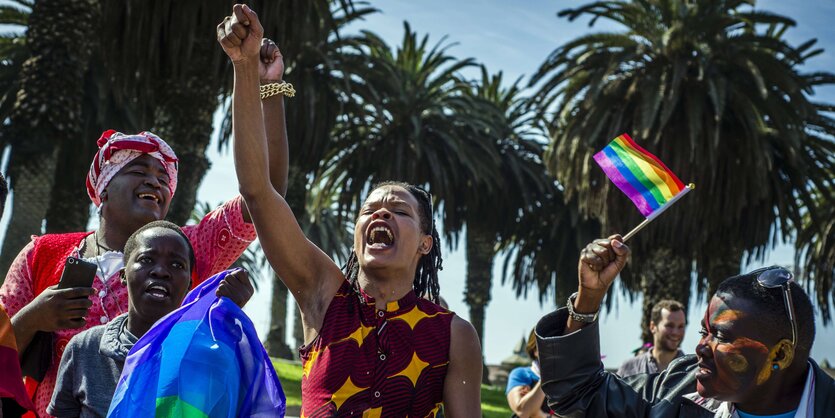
[217,4,343,329]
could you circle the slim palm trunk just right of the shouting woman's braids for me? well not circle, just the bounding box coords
[464,222,496,384]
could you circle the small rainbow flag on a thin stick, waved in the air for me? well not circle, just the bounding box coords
[594,134,690,218]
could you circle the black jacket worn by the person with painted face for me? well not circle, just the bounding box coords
[536,308,835,418]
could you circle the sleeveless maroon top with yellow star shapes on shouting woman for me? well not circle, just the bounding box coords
[299,280,454,418]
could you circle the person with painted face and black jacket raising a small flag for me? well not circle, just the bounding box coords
[536,235,835,418]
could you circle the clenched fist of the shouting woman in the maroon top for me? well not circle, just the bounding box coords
[217,4,264,63]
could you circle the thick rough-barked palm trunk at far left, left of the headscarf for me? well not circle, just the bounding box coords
[0,0,99,277]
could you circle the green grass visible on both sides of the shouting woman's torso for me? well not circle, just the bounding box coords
[273,359,511,418]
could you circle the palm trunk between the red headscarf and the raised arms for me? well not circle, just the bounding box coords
[154,43,219,225]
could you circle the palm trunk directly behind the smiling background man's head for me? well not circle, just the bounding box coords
[640,248,692,343]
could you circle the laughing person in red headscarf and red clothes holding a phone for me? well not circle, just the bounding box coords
[0,40,288,417]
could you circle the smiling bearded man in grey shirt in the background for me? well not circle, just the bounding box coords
[618,299,687,377]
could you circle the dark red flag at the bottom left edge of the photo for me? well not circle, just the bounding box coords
[0,306,35,415]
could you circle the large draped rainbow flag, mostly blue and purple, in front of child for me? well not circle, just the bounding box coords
[107,271,285,418]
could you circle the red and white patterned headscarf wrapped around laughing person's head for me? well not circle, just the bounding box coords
[87,129,177,206]
